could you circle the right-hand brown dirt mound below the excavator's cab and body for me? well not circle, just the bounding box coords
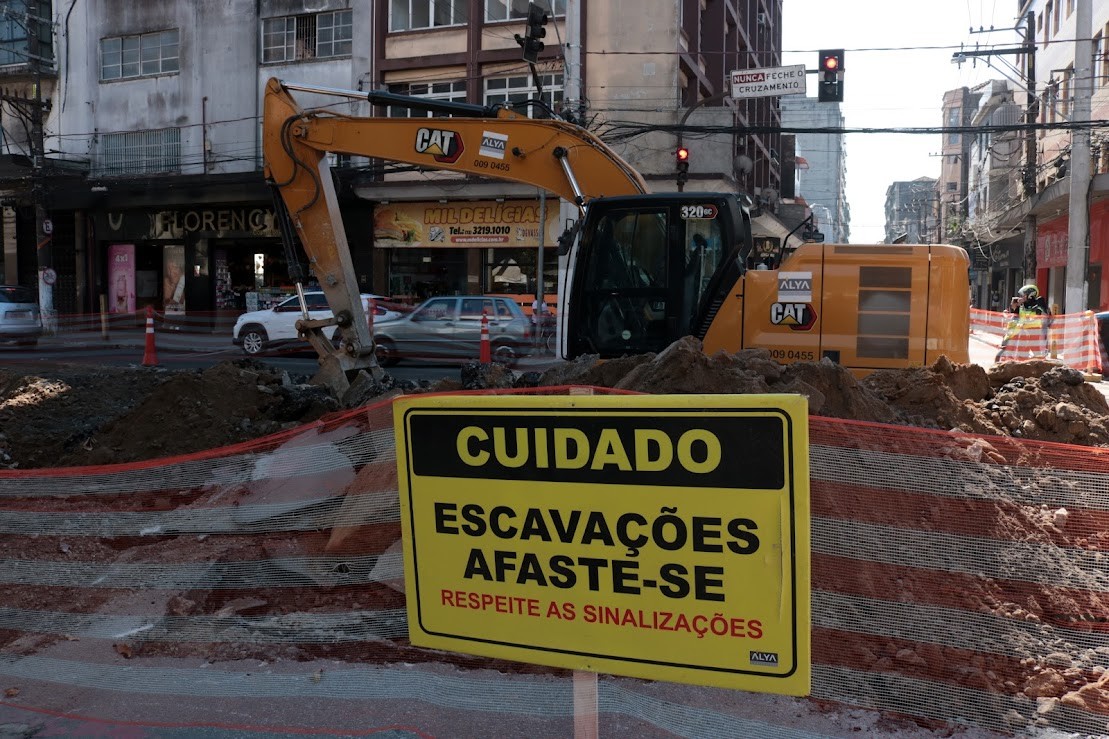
[527,337,1109,446]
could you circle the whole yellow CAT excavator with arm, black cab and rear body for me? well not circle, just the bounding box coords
[263,79,970,393]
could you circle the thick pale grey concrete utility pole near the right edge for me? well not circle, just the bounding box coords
[1064,0,1093,313]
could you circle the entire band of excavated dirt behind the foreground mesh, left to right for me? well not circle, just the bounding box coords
[0,338,1109,469]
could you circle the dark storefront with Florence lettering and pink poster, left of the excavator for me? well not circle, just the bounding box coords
[92,205,294,316]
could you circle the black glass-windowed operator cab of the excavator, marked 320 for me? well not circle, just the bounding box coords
[562,192,752,357]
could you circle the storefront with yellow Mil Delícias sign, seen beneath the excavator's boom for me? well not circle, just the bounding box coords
[374,199,559,306]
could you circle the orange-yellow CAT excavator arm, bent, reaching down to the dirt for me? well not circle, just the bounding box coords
[262,79,647,394]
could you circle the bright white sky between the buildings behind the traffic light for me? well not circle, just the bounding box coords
[782,0,1024,244]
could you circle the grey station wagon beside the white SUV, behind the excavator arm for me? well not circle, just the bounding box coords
[374,295,533,367]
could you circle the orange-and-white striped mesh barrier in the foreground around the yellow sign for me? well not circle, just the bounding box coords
[0,388,1109,737]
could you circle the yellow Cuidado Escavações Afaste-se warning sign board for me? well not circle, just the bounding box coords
[395,395,811,695]
